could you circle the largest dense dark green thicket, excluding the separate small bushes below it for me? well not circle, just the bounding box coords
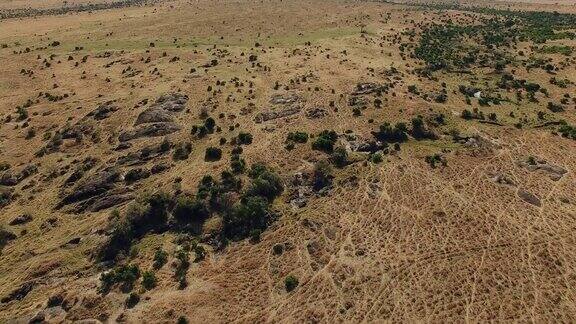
[97,163,284,266]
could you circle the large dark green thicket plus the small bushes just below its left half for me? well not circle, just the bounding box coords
[98,164,284,292]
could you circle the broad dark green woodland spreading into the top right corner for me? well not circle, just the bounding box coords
[414,5,576,74]
